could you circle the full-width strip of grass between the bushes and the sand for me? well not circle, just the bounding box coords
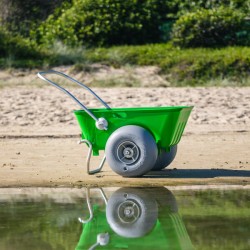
[0,43,250,86]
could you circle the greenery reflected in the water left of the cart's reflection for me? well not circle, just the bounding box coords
[0,200,82,249]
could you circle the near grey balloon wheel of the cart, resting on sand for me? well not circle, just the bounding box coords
[105,125,157,177]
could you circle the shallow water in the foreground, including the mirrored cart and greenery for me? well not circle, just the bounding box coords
[0,187,250,250]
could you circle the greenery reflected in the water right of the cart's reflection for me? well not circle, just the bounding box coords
[176,190,250,250]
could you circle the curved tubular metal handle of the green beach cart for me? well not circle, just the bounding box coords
[37,70,111,126]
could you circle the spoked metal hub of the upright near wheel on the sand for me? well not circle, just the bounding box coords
[117,141,140,164]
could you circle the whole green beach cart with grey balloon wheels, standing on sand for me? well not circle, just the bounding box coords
[38,70,193,177]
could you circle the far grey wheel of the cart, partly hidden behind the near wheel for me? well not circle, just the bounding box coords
[152,145,177,171]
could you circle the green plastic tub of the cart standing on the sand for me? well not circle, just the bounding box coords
[74,106,192,155]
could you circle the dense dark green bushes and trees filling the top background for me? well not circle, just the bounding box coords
[0,0,250,51]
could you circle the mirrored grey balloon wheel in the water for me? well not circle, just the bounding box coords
[106,188,158,238]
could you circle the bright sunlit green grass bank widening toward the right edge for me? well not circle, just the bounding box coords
[85,44,250,86]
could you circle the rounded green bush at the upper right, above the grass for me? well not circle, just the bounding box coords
[172,7,250,47]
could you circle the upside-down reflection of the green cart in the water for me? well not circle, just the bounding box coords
[76,187,193,250]
